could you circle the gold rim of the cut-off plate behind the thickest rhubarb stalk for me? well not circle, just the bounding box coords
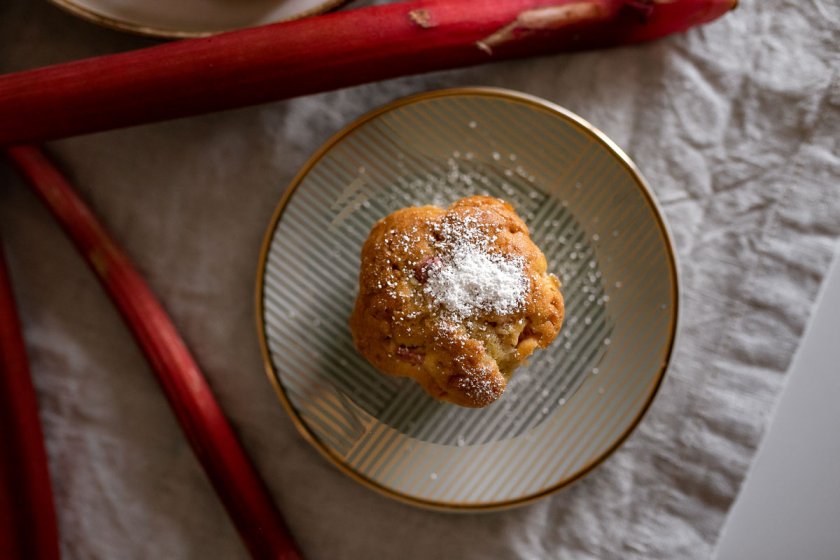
[47,0,350,39]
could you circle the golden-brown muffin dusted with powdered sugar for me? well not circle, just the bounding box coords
[350,196,564,408]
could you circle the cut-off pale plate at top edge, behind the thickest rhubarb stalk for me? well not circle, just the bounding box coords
[50,0,347,38]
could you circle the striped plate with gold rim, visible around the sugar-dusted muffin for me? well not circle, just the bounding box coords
[257,88,678,509]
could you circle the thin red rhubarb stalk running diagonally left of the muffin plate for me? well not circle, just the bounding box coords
[7,146,300,560]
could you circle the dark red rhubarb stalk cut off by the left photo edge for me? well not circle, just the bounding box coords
[0,237,59,560]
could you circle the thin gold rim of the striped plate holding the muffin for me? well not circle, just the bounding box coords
[255,86,681,512]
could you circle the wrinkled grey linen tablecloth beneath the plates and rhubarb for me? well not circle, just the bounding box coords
[0,0,840,560]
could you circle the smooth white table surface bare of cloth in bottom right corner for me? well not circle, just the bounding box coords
[717,248,840,560]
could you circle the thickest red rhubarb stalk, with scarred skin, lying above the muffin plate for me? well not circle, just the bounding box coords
[0,0,737,146]
